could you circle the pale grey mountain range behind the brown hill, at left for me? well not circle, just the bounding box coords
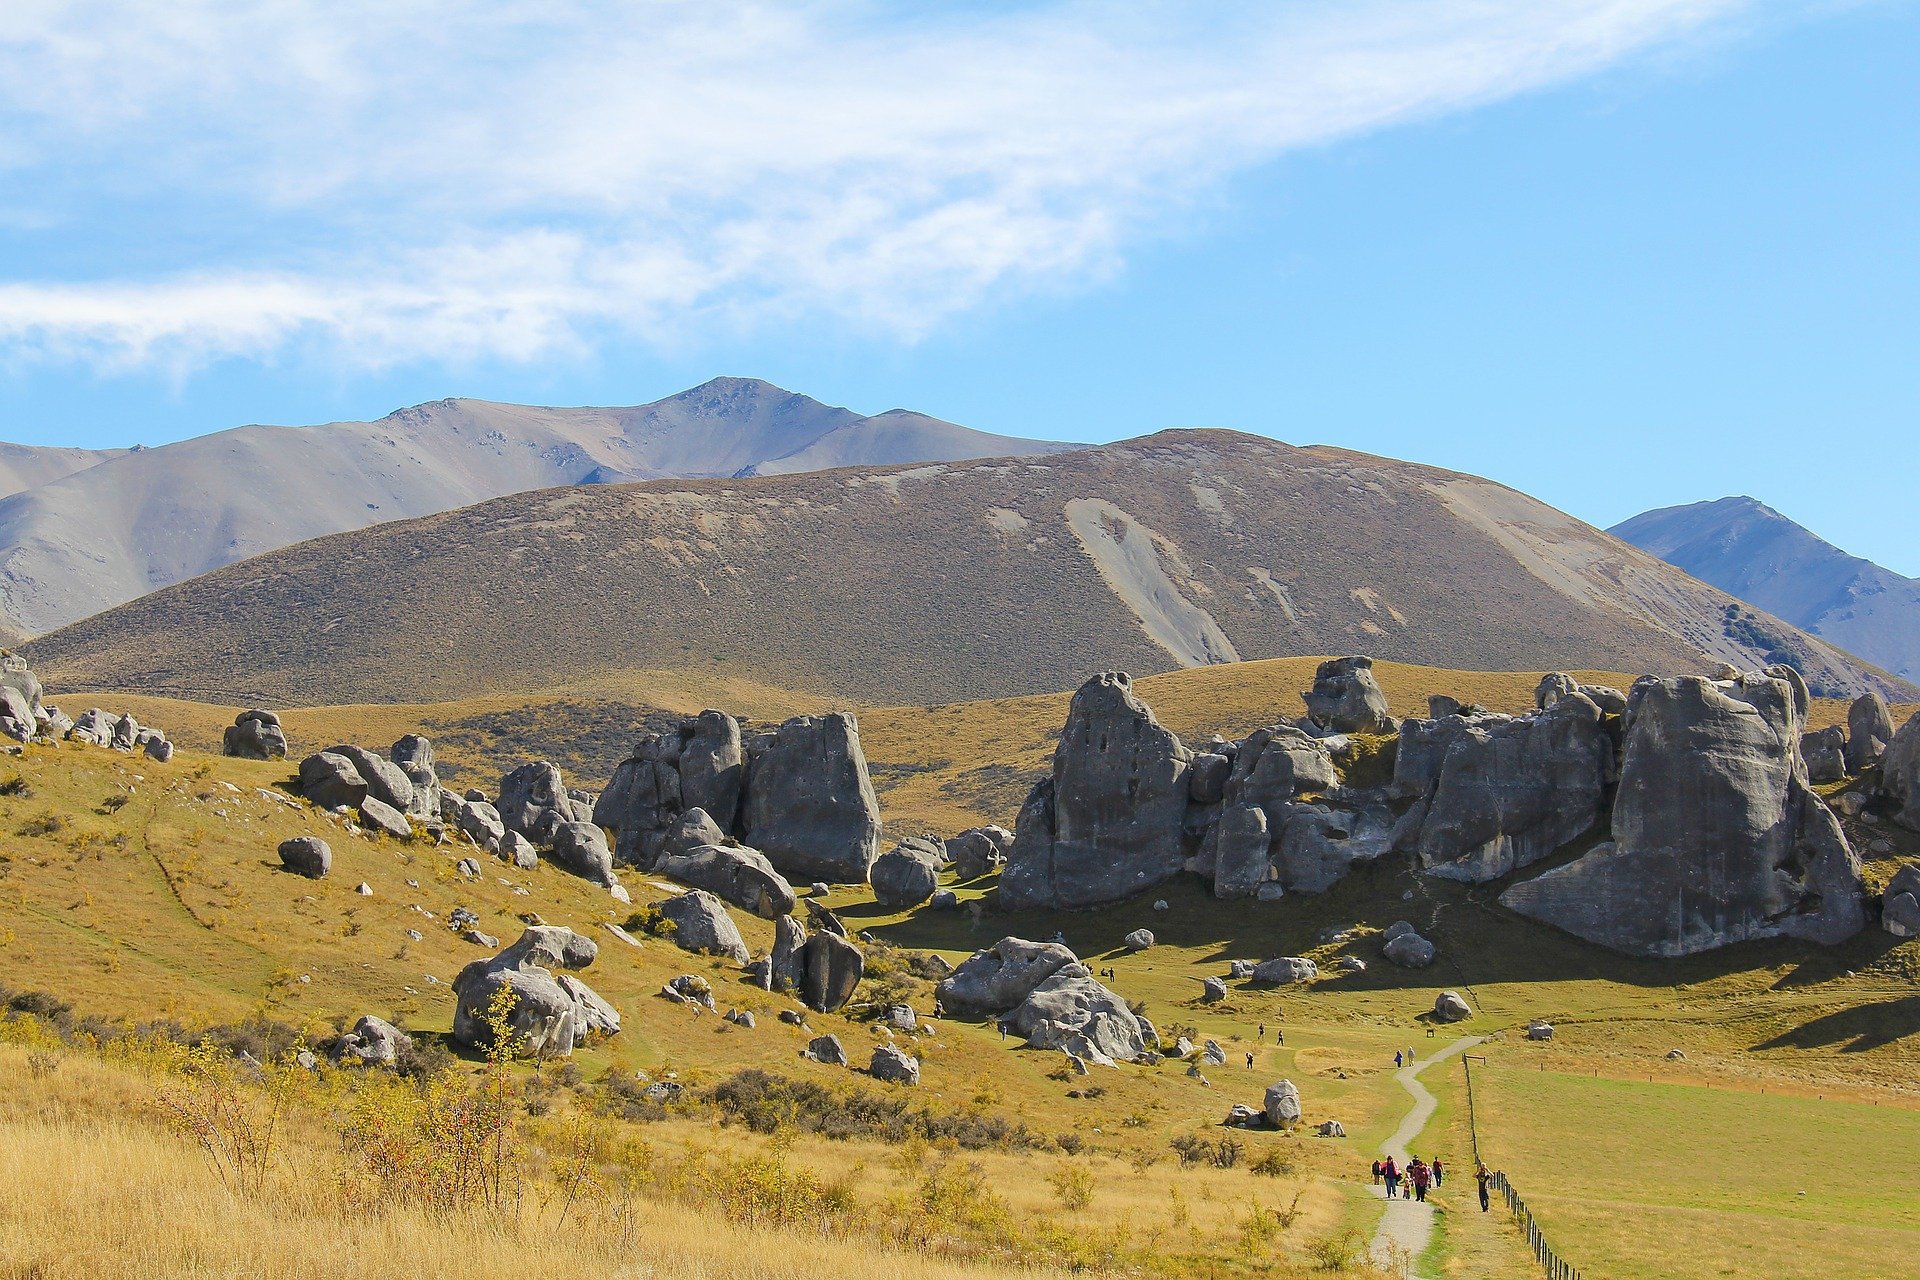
[0,378,1068,633]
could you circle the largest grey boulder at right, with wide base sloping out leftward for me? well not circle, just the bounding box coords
[1500,666,1866,956]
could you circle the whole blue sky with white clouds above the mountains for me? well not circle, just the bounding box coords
[0,0,1920,576]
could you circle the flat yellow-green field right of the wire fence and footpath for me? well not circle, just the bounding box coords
[1475,1057,1920,1280]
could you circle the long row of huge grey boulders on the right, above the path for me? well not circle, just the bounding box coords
[1000,658,1920,967]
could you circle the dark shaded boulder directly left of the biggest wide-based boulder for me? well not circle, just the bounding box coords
[1396,689,1615,885]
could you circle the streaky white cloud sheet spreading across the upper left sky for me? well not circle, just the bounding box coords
[0,0,1741,367]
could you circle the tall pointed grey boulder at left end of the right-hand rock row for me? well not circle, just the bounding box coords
[1000,672,1192,908]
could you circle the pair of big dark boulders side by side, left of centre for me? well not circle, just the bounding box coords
[593,710,879,885]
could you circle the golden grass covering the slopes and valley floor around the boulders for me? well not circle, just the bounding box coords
[0,660,1920,1280]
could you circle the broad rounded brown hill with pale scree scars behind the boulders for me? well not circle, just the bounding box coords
[31,430,1916,706]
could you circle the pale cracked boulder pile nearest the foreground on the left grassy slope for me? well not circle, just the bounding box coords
[453,925,620,1055]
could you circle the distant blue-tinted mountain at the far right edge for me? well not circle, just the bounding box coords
[1611,497,1920,679]
